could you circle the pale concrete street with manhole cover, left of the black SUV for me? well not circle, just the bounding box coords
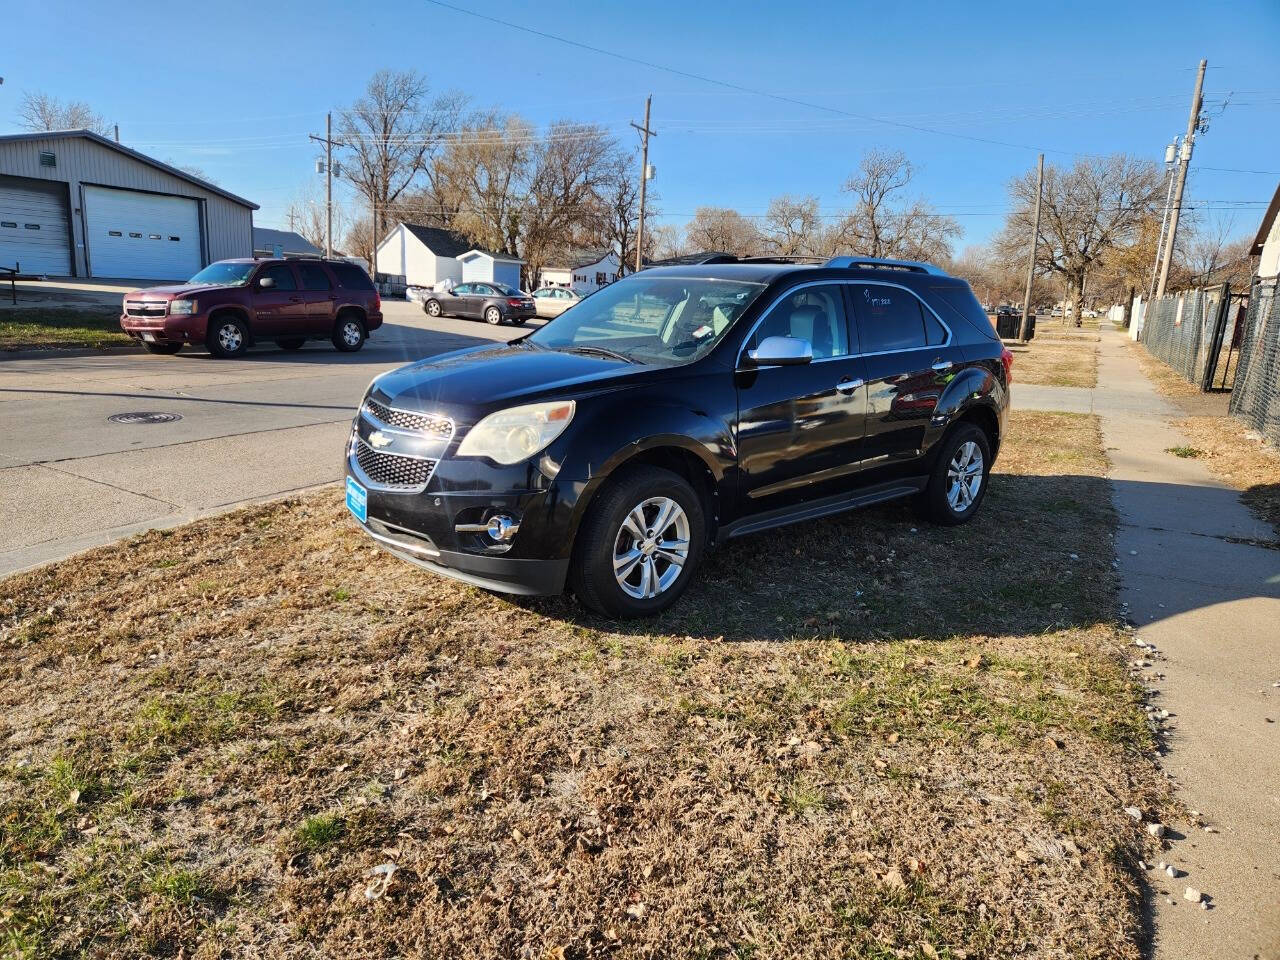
[0,302,540,575]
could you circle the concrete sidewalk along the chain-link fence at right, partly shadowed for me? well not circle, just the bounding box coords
[1014,326,1280,960]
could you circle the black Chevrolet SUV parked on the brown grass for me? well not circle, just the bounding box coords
[347,257,1012,616]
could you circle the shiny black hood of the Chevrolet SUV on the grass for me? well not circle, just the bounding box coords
[372,342,662,419]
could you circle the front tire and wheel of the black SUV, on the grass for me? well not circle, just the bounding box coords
[570,467,707,618]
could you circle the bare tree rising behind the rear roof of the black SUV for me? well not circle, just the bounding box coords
[831,150,963,264]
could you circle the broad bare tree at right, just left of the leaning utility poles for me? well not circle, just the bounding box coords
[996,154,1164,319]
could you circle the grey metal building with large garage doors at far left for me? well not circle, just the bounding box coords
[0,131,257,280]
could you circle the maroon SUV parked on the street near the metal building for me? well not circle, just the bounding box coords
[120,260,383,357]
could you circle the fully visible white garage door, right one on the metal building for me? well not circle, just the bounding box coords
[84,187,204,280]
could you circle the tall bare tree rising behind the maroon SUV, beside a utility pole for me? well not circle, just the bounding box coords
[335,70,465,262]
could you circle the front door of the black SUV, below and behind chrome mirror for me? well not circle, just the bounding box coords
[735,283,867,512]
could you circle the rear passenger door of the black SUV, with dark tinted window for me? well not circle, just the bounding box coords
[849,280,964,479]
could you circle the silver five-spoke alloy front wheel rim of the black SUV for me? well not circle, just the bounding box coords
[613,497,689,600]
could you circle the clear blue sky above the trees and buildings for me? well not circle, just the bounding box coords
[0,0,1280,252]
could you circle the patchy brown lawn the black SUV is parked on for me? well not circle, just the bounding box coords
[0,413,1166,959]
